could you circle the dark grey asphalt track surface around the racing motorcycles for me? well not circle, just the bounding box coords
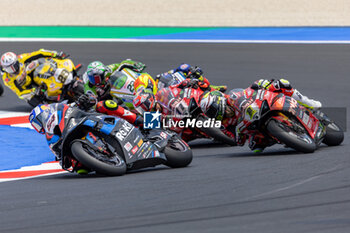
[0,43,350,233]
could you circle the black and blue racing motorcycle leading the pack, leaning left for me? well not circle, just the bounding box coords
[34,103,192,176]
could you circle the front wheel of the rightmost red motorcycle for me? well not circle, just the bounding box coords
[266,119,317,153]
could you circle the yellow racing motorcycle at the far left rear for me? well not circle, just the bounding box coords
[27,58,84,107]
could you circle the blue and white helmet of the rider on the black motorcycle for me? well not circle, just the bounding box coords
[29,104,49,134]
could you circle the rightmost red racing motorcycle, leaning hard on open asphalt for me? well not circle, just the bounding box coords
[230,88,344,153]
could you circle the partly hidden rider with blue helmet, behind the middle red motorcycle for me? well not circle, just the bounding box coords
[156,63,227,92]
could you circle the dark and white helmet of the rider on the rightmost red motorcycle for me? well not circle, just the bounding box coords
[200,91,226,120]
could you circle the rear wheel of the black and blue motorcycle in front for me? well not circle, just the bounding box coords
[164,136,193,168]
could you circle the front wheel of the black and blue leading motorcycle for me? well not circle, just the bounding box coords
[71,140,126,176]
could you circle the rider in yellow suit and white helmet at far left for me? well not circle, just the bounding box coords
[0,49,69,101]
